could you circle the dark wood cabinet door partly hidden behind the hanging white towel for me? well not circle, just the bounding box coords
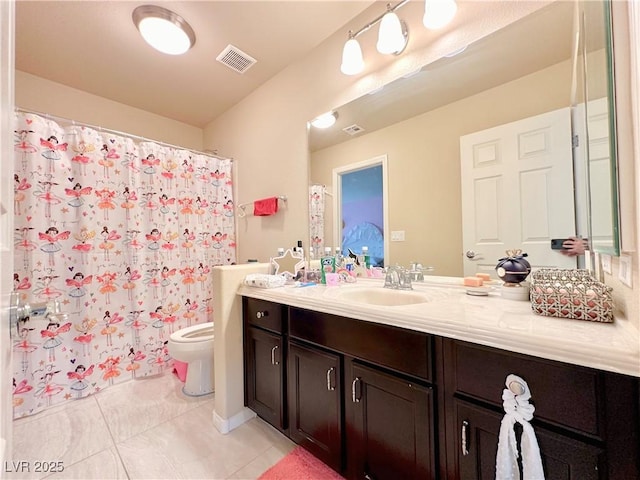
[453,400,603,480]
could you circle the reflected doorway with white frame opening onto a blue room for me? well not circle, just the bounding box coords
[333,155,389,266]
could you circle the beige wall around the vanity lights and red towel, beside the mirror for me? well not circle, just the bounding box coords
[204,2,545,261]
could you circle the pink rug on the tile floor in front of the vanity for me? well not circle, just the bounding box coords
[258,447,344,480]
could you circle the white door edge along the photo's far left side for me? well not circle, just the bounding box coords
[0,1,14,464]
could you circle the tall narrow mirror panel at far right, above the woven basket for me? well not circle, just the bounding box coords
[575,1,619,255]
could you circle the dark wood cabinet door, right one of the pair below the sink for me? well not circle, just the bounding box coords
[346,361,436,480]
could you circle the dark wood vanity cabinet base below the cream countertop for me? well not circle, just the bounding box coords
[243,298,640,480]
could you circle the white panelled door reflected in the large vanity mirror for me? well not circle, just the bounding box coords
[460,108,576,276]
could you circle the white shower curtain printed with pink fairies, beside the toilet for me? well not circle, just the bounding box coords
[13,113,235,418]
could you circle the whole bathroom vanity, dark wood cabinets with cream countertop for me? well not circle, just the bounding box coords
[239,281,640,480]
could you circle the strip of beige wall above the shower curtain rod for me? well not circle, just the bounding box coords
[15,71,202,150]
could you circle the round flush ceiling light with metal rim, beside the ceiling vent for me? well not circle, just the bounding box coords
[132,5,196,55]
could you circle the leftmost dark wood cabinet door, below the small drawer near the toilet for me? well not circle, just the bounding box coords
[245,327,286,430]
